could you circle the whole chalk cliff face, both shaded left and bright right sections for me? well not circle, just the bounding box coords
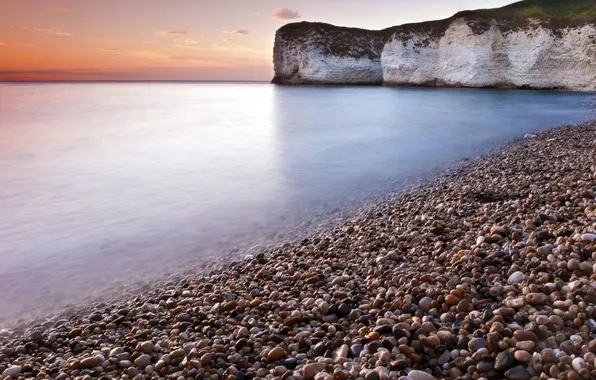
[273,12,596,91]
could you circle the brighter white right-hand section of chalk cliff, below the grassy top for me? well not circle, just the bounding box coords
[381,19,596,90]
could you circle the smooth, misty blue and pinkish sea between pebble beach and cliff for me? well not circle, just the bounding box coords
[0,83,596,327]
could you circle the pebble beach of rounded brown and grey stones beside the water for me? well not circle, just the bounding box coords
[0,122,596,380]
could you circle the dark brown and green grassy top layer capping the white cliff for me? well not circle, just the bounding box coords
[276,0,596,60]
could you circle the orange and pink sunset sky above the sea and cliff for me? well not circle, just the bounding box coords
[0,0,513,81]
